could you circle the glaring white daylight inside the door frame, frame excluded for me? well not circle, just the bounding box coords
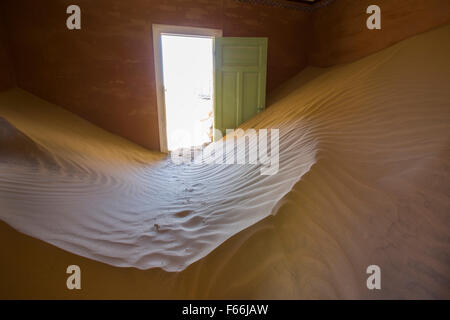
[161,34,214,151]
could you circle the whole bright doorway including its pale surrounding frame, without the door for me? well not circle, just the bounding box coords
[153,25,221,152]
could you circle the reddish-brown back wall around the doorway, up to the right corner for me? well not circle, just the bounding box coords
[3,0,310,150]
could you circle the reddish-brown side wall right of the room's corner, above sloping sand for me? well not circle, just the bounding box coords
[309,0,450,66]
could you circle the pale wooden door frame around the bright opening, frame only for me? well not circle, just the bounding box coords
[152,24,223,153]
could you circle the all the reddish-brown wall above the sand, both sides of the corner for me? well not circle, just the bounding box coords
[4,0,450,150]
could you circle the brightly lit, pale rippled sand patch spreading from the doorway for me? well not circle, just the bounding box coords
[0,92,315,271]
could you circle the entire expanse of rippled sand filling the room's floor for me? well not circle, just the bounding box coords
[0,26,450,298]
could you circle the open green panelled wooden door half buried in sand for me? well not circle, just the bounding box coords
[214,38,267,139]
